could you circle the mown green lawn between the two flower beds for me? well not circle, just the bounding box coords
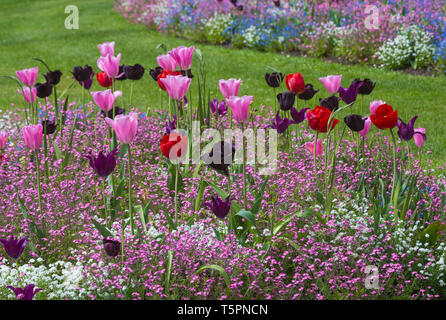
[0,0,446,164]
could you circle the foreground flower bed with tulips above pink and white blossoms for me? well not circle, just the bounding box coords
[0,43,446,299]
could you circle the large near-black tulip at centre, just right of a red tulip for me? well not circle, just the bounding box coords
[202,141,235,175]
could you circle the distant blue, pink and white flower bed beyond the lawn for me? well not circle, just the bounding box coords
[115,0,446,72]
